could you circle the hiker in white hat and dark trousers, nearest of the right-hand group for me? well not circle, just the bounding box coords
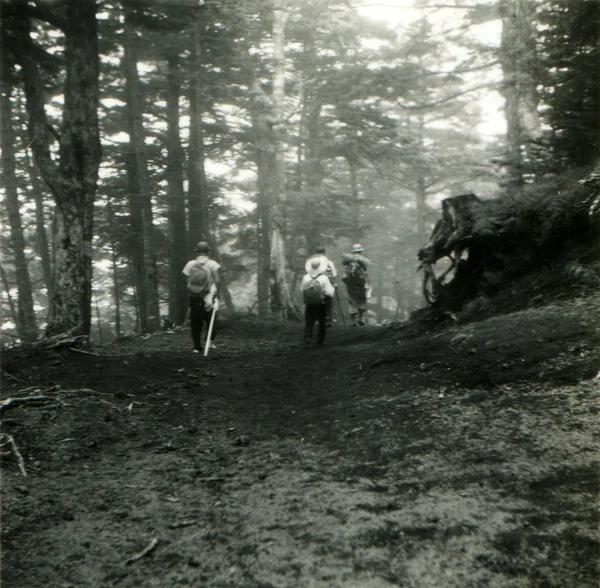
[300,259,335,347]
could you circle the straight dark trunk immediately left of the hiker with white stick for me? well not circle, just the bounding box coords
[167,53,188,325]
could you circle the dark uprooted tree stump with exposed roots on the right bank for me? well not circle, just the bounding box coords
[418,172,600,312]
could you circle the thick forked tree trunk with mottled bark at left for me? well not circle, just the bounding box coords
[14,0,101,335]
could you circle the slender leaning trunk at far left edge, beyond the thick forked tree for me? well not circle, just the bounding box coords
[0,63,37,341]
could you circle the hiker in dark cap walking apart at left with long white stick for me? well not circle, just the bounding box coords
[183,241,221,353]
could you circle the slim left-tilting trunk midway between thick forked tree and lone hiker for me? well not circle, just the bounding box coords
[123,8,160,333]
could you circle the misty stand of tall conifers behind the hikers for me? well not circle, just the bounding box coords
[0,0,600,342]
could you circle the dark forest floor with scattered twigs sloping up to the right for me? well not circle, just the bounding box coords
[2,296,600,588]
